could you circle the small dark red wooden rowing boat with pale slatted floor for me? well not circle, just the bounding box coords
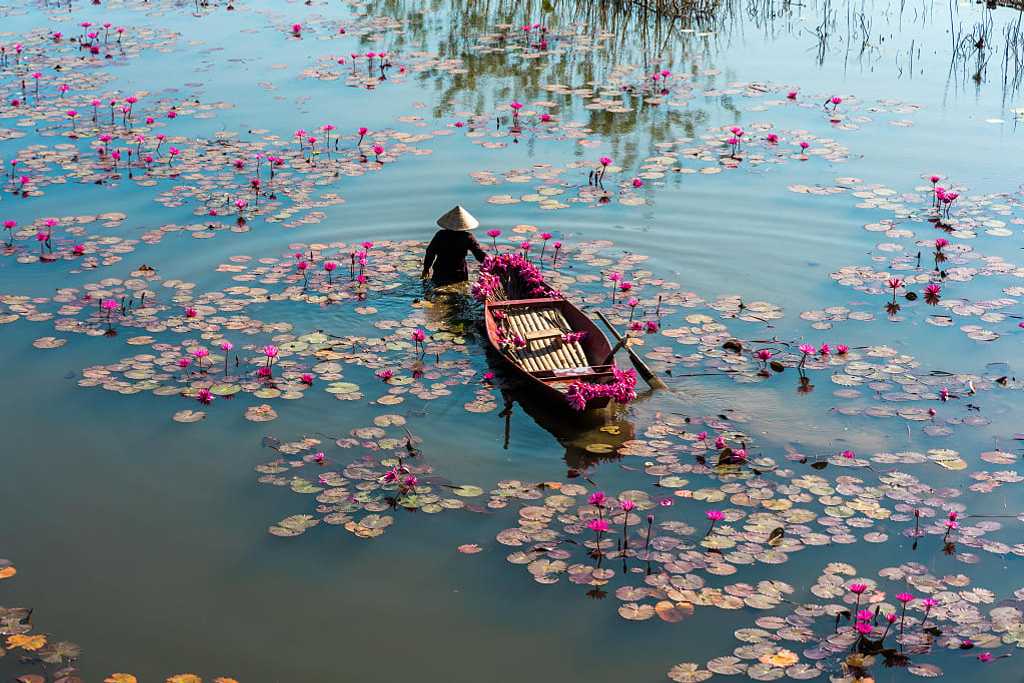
[483,297,618,413]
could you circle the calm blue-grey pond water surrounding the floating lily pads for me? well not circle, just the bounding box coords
[0,0,1024,681]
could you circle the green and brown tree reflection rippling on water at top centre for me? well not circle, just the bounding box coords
[366,0,717,165]
